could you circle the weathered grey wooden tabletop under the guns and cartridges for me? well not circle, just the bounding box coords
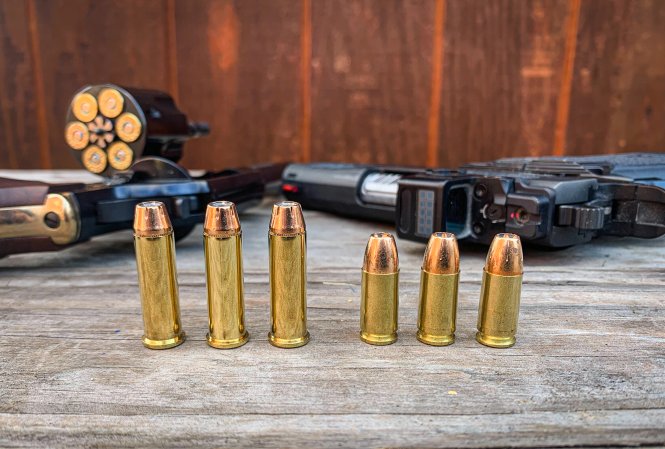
[0,172,665,448]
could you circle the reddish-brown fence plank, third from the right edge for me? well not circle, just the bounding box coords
[312,0,434,165]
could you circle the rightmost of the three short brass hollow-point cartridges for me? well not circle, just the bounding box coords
[476,234,524,348]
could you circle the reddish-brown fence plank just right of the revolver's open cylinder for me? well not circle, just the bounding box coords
[176,0,302,169]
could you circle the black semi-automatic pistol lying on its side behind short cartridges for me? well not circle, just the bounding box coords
[282,153,665,248]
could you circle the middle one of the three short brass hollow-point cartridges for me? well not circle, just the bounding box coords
[416,232,459,346]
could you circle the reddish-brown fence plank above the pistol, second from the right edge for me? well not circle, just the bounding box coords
[439,0,567,166]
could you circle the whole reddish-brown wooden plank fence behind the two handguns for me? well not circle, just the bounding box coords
[0,0,665,168]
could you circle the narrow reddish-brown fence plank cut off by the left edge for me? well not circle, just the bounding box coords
[0,0,44,168]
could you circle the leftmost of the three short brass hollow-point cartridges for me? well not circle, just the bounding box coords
[360,232,399,345]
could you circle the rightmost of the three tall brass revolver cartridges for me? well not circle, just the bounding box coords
[268,201,309,348]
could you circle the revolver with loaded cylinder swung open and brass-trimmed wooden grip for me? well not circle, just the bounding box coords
[0,84,285,257]
